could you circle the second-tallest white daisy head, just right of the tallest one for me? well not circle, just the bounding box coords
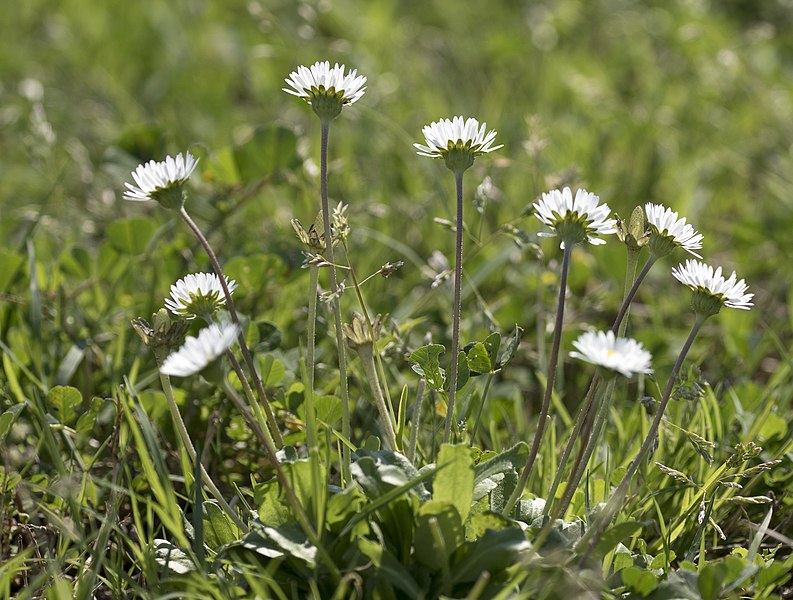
[413,116,503,173]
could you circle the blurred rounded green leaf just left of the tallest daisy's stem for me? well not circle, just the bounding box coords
[233,125,300,185]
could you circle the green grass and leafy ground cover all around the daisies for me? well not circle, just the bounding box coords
[0,0,793,598]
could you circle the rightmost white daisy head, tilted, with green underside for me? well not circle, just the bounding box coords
[672,259,754,317]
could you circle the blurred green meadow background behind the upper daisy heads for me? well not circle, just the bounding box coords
[0,0,793,408]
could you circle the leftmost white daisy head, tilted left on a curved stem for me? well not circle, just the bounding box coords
[123,152,198,210]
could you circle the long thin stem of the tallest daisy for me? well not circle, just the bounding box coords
[319,119,350,486]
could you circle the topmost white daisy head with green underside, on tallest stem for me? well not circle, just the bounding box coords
[282,60,366,120]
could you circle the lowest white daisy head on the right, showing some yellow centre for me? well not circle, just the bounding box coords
[570,331,653,377]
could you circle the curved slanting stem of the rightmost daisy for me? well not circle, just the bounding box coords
[577,316,707,553]
